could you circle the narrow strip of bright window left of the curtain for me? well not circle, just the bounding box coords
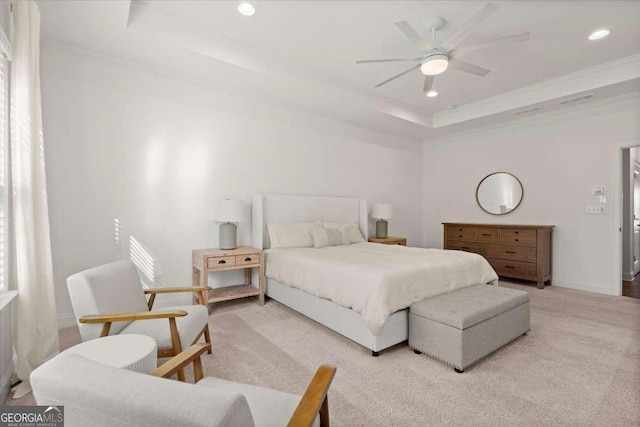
[0,56,9,292]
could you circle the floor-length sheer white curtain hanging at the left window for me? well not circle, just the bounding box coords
[10,0,58,398]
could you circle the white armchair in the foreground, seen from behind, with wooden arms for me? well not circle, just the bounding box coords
[31,344,336,427]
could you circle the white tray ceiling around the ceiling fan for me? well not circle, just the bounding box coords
[39,0,640,139]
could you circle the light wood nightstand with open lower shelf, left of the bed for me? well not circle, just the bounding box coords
[193,246,264,305]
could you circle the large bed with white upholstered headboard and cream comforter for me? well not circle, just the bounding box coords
[252,194,497,356]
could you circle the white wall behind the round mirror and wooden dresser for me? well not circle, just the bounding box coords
[423,96,640,294]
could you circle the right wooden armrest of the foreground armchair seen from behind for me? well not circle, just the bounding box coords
[287,365,336,427]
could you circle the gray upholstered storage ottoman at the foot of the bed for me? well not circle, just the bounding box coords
[409,285,531,372]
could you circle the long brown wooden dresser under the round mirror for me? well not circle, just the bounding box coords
[443,222,553,289]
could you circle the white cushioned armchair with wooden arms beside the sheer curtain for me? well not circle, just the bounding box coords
[67,261,211,381]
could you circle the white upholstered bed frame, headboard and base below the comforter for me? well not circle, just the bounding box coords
[251,194,409,356]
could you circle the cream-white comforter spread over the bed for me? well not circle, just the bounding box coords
[266,243,498,335]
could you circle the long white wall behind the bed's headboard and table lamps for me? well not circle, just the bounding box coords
[42,43,422,324]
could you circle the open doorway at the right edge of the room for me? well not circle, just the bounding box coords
[621,147,640,298]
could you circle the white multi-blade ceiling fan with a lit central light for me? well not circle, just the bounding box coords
[356,3,531,92]
